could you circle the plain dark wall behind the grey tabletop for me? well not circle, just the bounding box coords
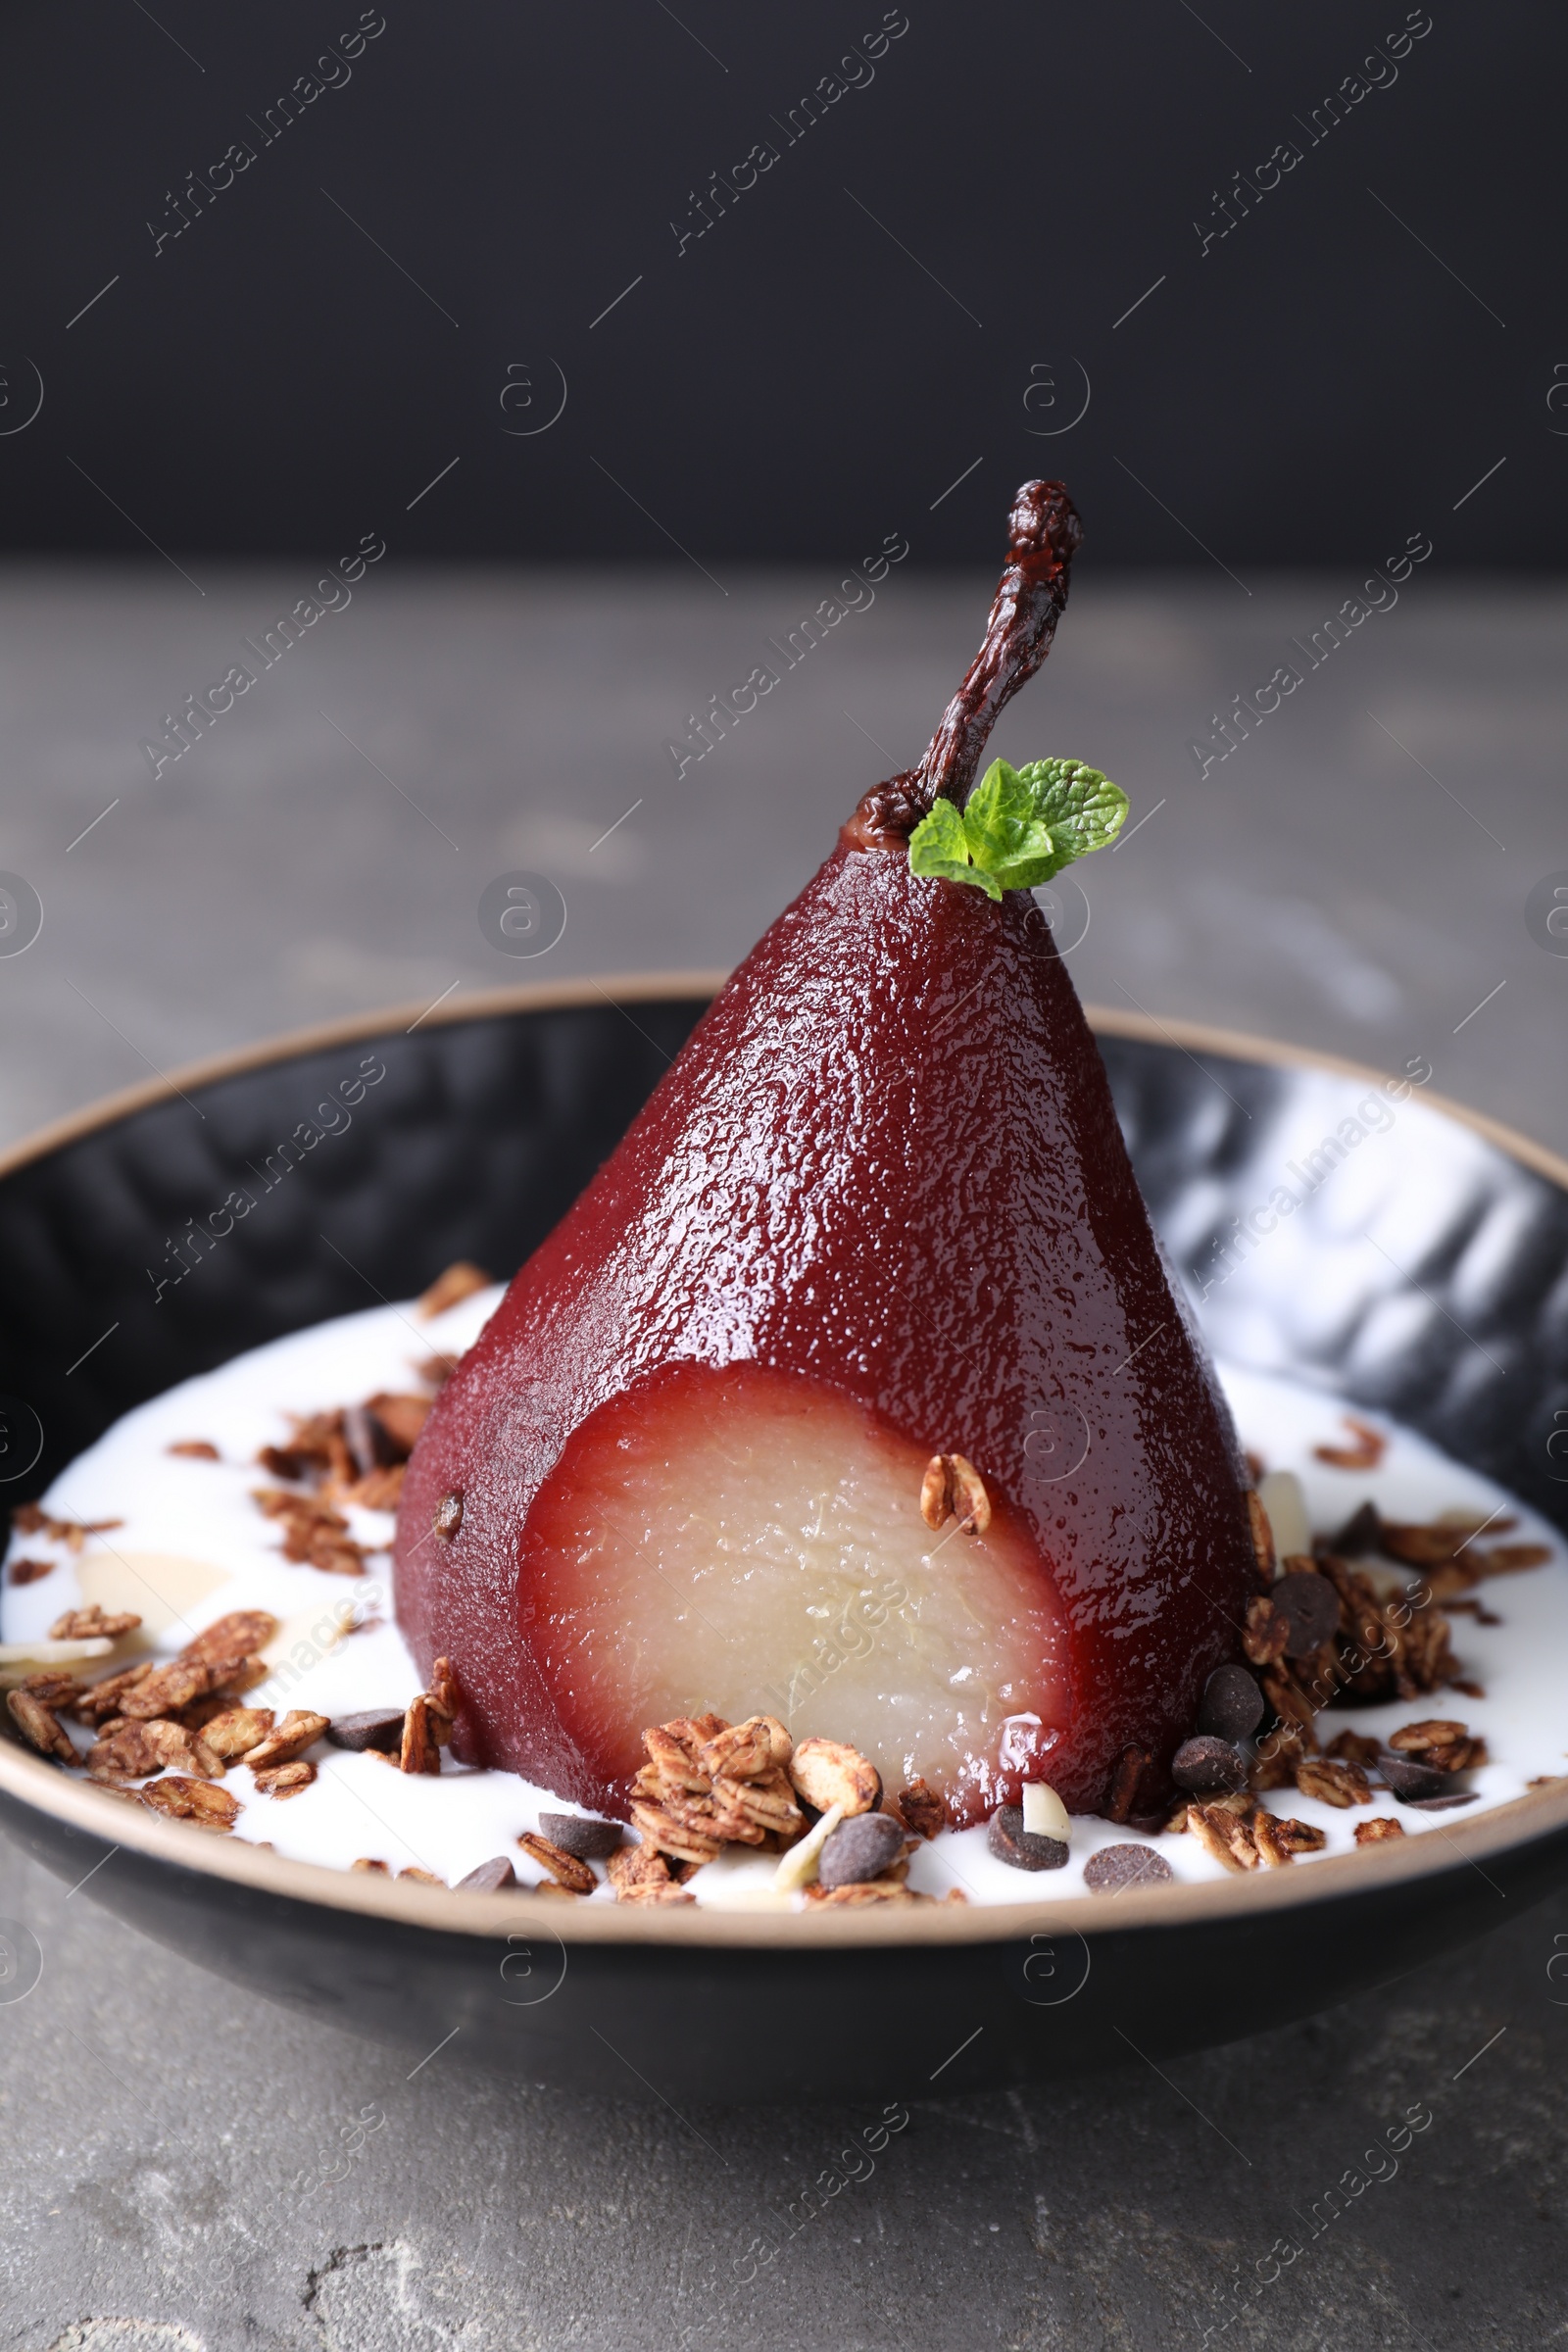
[0,0,1568,576]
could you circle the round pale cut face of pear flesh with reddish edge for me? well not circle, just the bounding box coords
[519,1364,1067,1789]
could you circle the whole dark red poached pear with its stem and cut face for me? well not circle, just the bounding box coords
[395,482,1255,1825]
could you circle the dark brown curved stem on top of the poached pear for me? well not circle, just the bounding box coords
[842,482,1084,849]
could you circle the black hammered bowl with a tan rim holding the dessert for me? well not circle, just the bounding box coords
[0,974,1568,2103]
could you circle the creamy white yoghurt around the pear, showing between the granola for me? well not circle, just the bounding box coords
[0,1287,1568,1907]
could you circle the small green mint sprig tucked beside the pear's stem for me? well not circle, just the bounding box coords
[909,760,1126,899]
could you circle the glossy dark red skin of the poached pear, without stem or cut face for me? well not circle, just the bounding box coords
[395,847,1255,1818]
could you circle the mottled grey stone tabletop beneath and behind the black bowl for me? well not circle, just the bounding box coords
[0,560,1568,2352]
